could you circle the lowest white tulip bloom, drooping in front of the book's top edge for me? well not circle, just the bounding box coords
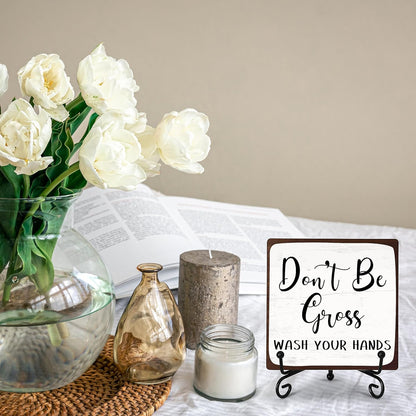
[79,112,146,191]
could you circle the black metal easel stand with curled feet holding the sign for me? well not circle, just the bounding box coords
[276,351,386,399]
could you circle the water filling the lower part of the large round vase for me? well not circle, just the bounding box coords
[0,270,115,392]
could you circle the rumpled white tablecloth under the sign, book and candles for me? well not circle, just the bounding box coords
[117,218,416,416]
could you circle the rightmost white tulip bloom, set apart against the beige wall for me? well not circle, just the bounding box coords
[155,108,211,173]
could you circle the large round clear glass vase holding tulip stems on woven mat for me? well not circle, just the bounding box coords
[0,194,115,392]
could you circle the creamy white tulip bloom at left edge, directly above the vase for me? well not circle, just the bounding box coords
[0,98,53,175]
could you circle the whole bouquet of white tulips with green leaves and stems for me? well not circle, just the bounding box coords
[0,45,210,304]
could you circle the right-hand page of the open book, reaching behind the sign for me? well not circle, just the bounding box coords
[161,196,302,293]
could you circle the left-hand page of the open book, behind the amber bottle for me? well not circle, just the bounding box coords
[74,185,205,286]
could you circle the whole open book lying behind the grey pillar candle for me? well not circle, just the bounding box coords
[74,185,302,298]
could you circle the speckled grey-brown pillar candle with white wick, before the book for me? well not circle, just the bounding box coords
[178,250,240,349]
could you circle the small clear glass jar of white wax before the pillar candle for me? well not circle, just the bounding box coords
[194,324,257,402]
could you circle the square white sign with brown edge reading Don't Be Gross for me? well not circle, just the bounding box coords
[267,239,398,369]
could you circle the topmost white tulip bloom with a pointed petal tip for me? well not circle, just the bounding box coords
[77,44,139,122]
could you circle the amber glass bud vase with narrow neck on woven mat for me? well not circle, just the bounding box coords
[114,263,186,384]
